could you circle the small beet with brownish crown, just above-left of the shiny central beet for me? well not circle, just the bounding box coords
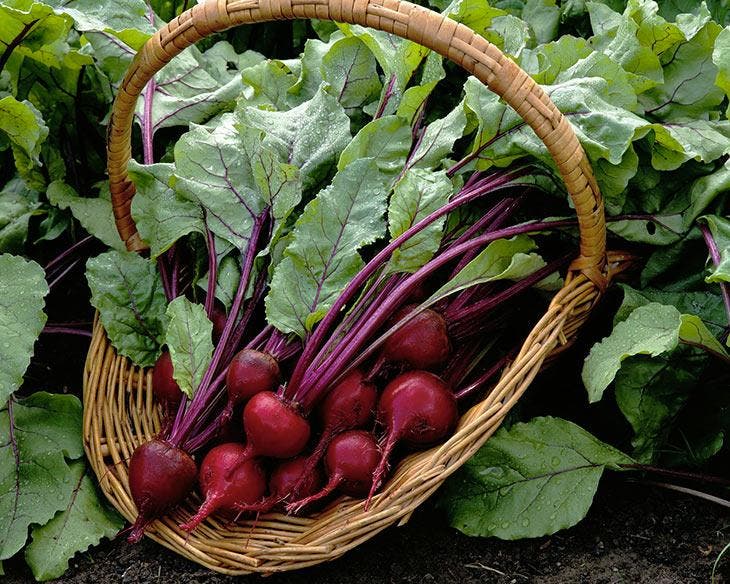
[223,349,281,419]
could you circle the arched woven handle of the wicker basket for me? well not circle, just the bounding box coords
[107,0,606,290]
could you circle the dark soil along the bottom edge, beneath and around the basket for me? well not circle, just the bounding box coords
[5,476,730,584]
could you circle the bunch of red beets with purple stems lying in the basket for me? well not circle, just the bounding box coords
[129,162,573,541]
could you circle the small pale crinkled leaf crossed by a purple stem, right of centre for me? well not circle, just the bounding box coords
[387,168,453,272]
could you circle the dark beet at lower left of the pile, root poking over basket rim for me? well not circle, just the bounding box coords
[127,439,198,543]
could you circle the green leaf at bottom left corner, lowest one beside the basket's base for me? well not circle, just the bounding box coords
[25,461,124,581]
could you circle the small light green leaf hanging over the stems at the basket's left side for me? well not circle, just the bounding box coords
[165,296,213,399]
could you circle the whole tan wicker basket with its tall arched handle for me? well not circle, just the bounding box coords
[84,0,608,574]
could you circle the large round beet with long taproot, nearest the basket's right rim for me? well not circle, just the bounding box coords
[368,371,458,501]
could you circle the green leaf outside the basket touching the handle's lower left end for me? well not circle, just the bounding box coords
[46,181,126,251]
